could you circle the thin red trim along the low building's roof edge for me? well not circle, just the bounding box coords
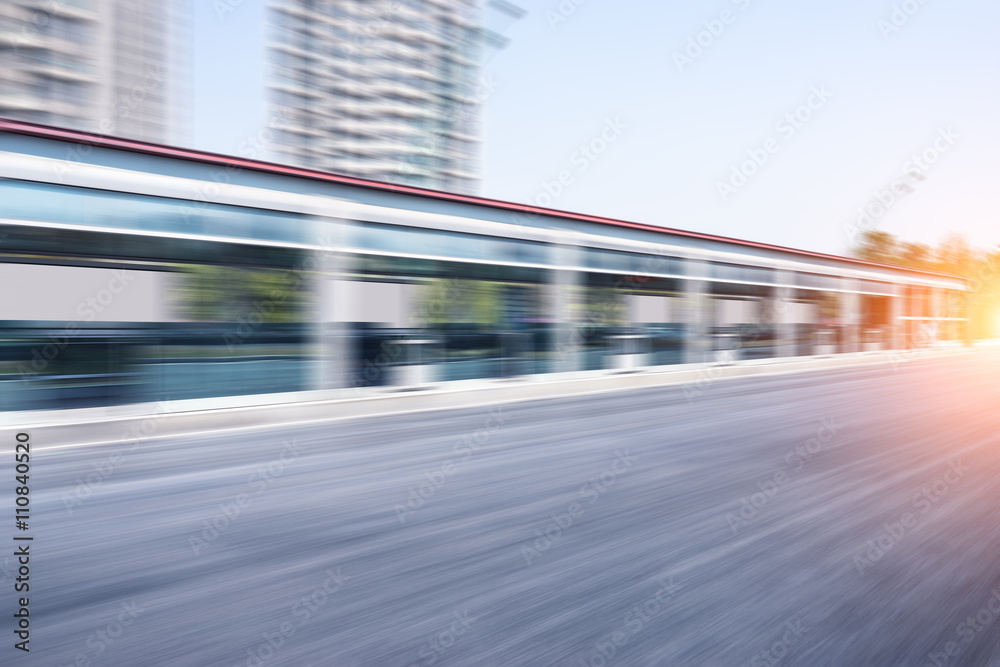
[0,118,958,279]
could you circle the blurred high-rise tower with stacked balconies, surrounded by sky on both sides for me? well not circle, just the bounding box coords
[267,0,523,193]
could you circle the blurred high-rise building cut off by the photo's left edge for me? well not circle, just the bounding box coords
[0,0,189,143]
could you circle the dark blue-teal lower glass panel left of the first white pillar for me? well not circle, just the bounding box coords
[0,322,310,410]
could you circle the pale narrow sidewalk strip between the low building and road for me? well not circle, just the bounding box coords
[0,344,984,449]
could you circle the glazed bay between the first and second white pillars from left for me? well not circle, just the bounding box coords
[345,254,553,387]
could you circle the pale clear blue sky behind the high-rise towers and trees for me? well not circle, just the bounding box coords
[193,0,1000,253]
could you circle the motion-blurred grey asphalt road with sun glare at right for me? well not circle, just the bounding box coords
[0,350,1000,667]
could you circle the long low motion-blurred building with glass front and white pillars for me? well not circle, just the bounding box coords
[0,120,967,412]
